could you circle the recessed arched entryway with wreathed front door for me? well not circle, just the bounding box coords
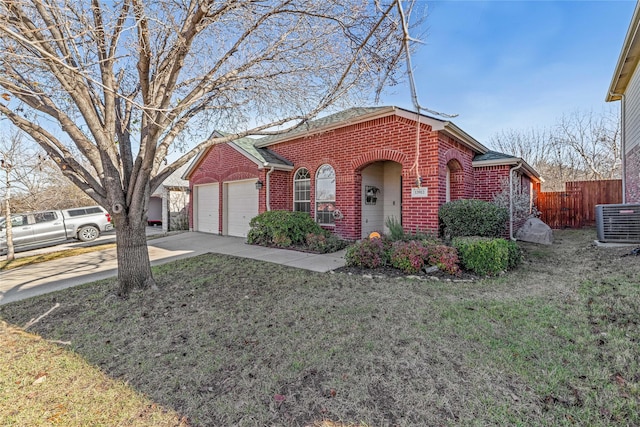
[361,161,402,237]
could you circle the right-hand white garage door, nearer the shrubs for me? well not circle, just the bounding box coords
[226,180,258,237]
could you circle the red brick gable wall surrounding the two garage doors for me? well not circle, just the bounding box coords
[189,144,266,230]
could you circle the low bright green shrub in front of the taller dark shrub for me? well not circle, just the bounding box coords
[452,237,522,276]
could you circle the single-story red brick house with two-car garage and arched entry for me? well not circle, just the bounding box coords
[184,107,540,239]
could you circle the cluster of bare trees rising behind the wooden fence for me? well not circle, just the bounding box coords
[489,109,620,191]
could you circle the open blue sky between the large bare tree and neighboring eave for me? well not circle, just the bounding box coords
[382,1,635,145]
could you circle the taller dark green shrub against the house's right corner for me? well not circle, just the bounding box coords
[438,199,509,239]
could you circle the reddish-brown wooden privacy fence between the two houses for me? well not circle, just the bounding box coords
[536,179,622,228]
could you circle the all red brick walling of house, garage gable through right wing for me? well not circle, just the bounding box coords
[185,116,528,239]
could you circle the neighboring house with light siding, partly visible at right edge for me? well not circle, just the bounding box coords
[606,3,640,203]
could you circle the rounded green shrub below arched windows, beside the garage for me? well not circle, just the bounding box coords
[247,211,329,247]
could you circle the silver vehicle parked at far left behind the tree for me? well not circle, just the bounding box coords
[0,206,112,254]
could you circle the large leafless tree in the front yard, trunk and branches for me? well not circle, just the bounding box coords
[0,0,415,295]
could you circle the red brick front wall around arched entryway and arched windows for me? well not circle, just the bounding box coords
[262,116,473,239]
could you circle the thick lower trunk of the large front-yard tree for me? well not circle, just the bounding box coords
[116,219,156,297]
